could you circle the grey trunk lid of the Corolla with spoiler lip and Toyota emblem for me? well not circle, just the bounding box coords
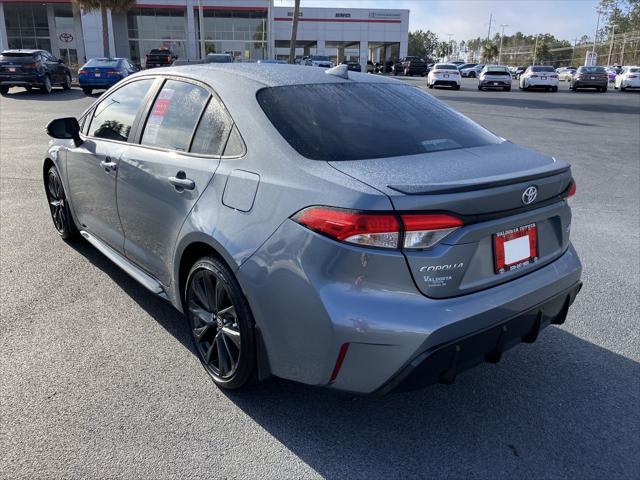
[330,142,571,298]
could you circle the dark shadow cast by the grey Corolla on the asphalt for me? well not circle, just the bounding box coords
[70,241,640,479]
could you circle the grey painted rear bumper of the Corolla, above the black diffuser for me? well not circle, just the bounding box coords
[237,221,582,394]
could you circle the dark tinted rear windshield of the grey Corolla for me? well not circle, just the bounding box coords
[257,83,501,161]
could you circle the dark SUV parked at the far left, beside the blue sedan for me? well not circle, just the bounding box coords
[0,50,71,95]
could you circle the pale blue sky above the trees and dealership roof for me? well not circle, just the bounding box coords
[274,0,598,40]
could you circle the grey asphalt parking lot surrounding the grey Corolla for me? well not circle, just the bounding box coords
[0,77,640,479]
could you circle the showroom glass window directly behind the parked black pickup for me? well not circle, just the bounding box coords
[127,8,187,64]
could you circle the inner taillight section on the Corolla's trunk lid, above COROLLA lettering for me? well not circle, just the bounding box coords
[401,213,463,249]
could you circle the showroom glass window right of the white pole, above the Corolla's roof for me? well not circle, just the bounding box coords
[194,9,267,60]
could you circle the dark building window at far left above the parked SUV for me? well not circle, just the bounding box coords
[4,3,51,51]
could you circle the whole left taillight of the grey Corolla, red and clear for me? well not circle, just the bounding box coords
[292,207,463,250]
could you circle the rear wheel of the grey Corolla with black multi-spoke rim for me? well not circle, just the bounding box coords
[184,256,257,390]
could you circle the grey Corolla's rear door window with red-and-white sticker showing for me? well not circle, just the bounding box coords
[141,80,209,152]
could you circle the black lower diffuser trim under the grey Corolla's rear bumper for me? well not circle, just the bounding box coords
[376,282,582,395]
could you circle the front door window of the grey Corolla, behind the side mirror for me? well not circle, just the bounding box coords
[89,78,154,142]
